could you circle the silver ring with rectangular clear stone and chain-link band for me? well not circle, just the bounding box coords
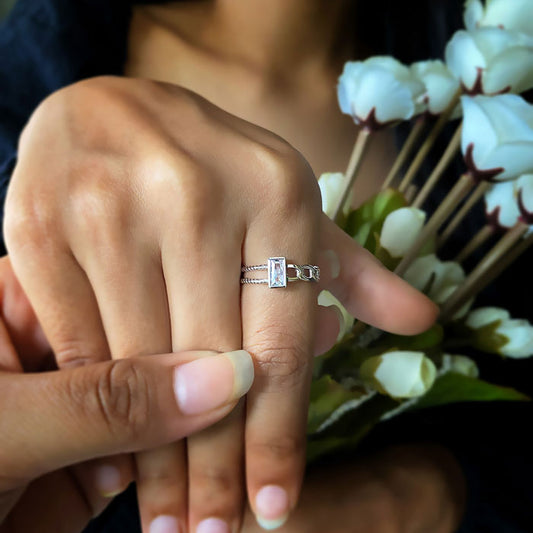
[241,257,320,289]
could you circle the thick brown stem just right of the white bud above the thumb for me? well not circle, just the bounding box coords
[394,174,475,276]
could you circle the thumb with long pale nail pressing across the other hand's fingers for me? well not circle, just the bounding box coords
[0,350,254,484]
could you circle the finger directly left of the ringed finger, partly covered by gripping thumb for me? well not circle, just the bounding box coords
[162,227,244,533]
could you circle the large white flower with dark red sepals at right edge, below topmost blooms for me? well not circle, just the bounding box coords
[461,94,533,181]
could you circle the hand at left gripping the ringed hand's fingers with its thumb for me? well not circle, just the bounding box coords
[0,257,253,533]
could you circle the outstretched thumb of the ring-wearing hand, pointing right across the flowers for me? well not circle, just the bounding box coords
[319,215,438,335]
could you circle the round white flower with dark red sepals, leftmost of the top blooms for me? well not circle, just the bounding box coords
[337,56,424,129]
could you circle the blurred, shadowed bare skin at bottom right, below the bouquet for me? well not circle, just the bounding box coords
[242,443,465,533]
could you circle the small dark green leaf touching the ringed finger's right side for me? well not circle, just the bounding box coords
[307,375,364,433]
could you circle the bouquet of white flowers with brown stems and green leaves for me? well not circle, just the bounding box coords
[308,0,533,460]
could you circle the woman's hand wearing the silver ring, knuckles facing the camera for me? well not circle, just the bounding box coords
[5,78,435,531]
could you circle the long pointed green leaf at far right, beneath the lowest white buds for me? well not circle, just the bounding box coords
[413,372,530,409]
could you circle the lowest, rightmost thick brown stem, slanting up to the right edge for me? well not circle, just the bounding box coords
[440,222,529,322]
